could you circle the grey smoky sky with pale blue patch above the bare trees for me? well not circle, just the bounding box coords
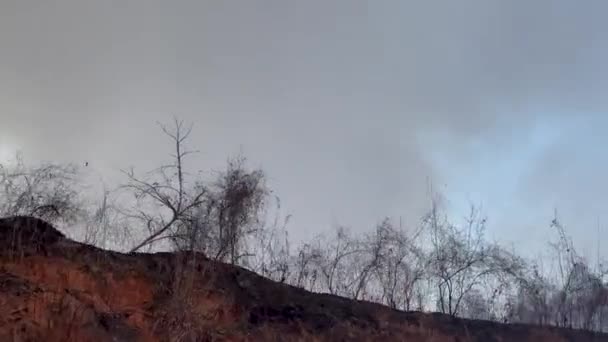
[0,0,608,256]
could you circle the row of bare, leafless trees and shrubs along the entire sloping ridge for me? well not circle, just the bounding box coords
[0,120,608,331]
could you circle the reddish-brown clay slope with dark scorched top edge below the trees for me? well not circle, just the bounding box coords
[0,218,608,342]
